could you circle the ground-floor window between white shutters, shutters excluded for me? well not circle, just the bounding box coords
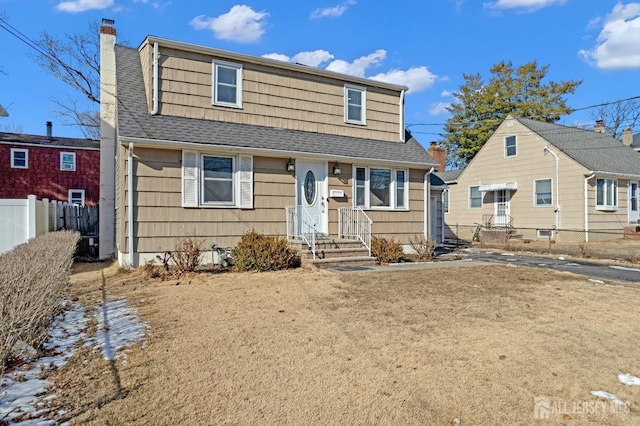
[202,155,233,204]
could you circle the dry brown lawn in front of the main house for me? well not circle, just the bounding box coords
[45,265,640,425]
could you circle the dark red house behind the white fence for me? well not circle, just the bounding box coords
[0,121,100,205]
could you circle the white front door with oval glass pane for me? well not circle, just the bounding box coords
[296,160,329,235]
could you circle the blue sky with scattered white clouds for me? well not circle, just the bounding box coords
[0,0,640,145]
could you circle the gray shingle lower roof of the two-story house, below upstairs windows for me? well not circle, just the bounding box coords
[116,45,437,168]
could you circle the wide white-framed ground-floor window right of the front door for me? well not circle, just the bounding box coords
[353,167,408,209]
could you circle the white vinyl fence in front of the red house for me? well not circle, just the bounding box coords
[0,195,73,254]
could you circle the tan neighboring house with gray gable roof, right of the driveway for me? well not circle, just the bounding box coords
[439,115,640,240]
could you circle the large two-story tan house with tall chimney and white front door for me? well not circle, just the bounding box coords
[100,22,443,266]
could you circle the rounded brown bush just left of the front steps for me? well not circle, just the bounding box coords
[232,230,300,271]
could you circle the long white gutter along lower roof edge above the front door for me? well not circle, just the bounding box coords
[120,136,438,169]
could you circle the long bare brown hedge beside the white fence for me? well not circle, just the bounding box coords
[0,231,80,371]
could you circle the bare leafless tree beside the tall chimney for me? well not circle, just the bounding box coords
[32,21,100,139]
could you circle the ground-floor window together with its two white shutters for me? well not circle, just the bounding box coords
[182,151,253,209]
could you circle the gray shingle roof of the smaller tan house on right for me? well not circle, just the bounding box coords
[513,117,640,175]
